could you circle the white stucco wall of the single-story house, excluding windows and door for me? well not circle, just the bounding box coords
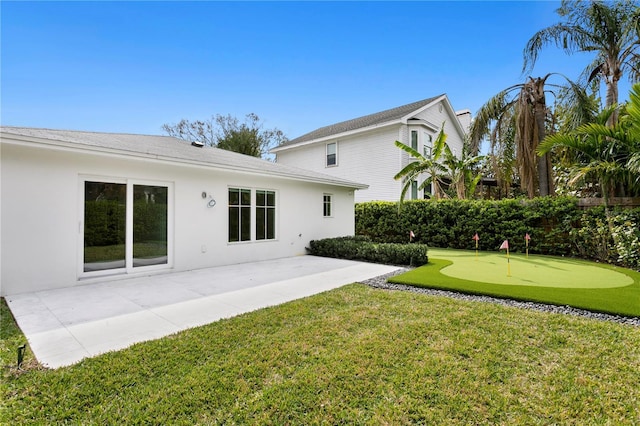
[0,139,355,295]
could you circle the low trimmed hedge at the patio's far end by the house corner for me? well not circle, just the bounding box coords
[309,236,429,266]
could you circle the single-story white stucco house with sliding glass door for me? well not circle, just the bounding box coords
[0,126,366,296]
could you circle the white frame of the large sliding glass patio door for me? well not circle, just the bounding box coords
[77,175,175,279]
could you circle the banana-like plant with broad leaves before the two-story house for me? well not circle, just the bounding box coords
[393,127,447,204]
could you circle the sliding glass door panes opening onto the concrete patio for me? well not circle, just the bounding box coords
[82,180,170,272]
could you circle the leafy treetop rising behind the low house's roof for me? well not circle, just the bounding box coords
[162,113,287,157]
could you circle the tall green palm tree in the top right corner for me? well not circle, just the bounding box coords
[523,0,640,126]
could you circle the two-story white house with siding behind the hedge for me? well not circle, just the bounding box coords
[271,94,471,202]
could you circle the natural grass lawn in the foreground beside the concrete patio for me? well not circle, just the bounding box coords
[0,284,640,424]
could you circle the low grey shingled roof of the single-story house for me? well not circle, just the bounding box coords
[0,126,368,189]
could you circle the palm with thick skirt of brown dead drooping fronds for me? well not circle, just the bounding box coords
[469,73,587,198]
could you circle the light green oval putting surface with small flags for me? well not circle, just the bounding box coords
[429,249,633,288]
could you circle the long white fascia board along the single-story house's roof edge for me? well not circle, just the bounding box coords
[0,133,369,189]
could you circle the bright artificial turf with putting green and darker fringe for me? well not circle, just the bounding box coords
[390,249,640,316]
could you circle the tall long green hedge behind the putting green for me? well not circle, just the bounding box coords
[355,197,640,268]
